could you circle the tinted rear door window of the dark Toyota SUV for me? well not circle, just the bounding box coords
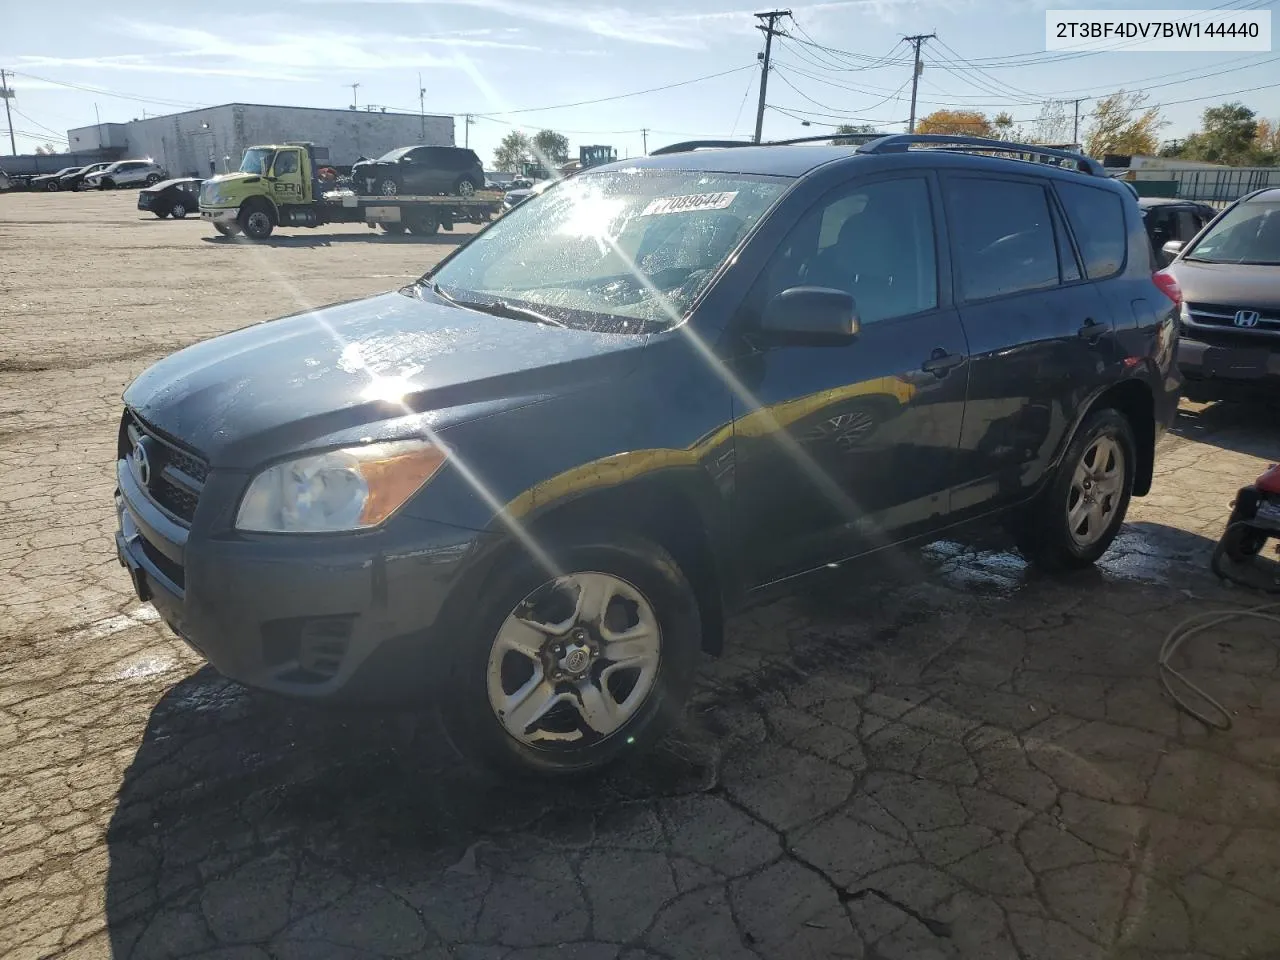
[946,177,1060,301]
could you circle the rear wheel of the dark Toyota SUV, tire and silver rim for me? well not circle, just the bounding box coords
[1018,408,1138,571]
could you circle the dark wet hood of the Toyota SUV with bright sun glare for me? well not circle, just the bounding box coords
[124,293,648,468]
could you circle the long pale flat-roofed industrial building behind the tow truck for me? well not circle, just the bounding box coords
[67,104,454,177]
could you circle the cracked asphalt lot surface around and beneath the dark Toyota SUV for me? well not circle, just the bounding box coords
[0,193,1280,960]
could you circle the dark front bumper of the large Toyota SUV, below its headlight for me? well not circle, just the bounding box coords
[115,460,489,705]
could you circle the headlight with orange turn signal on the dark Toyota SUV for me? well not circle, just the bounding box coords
[236,440,447,534]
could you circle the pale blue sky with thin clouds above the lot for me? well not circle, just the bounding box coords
[0,0,1280,166]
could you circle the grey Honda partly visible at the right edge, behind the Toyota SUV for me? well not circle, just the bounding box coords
[1165,187,1280,402]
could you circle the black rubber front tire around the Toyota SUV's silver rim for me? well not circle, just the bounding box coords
[440,536,701,777]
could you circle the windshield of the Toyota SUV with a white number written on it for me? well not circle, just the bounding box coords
[431,170,790,333]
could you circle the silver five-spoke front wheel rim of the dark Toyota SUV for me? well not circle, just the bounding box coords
[486,572,662,748]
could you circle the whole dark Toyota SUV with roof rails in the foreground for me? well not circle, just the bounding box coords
[115,136,1179,774]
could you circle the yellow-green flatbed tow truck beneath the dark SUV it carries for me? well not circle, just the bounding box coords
[200,142,502,239]
